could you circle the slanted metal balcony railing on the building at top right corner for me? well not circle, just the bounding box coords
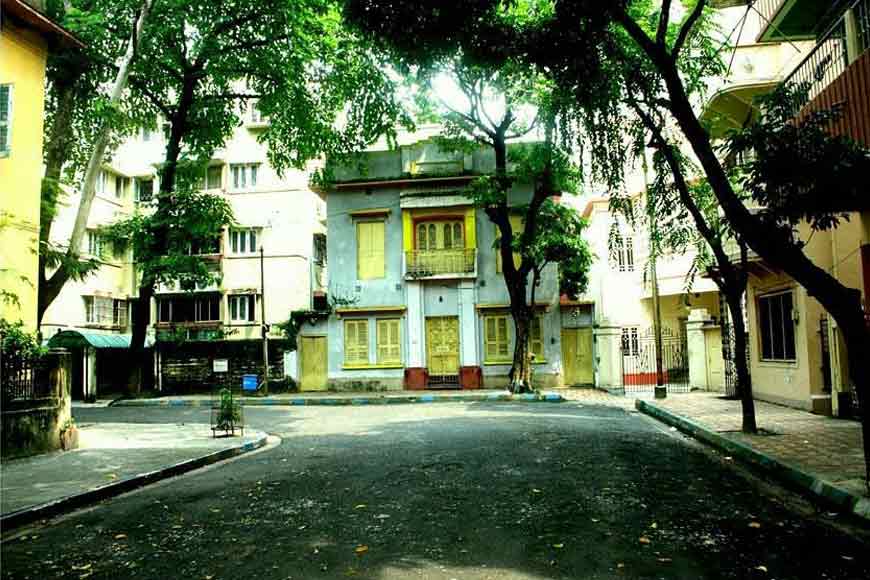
[783,0,870,115]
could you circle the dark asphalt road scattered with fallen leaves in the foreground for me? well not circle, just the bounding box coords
[2,403,870,580]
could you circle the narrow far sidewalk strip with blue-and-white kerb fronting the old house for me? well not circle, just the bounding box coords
[111,389,564,407]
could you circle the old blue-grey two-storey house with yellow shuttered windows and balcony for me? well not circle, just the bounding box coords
[288,127,593,390]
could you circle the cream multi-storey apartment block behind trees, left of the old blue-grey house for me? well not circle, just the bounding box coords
[44,107,326,397]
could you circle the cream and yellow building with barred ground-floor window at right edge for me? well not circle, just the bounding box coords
[704,0,870,415]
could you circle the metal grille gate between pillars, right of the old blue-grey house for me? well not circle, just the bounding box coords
[622,328,690,394]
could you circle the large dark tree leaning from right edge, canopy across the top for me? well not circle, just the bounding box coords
[348,0,870,483]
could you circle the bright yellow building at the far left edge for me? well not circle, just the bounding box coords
[0,0,80,330]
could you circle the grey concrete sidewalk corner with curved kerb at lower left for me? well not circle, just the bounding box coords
[0,423,266,528]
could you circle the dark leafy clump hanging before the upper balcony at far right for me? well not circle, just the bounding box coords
[724,83,870,230]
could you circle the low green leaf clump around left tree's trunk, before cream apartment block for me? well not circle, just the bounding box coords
[102,189,233,290]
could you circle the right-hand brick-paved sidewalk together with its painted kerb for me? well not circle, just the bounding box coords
[637,393,870,518]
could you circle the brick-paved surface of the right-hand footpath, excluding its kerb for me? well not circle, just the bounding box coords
[636,393,865,495]
